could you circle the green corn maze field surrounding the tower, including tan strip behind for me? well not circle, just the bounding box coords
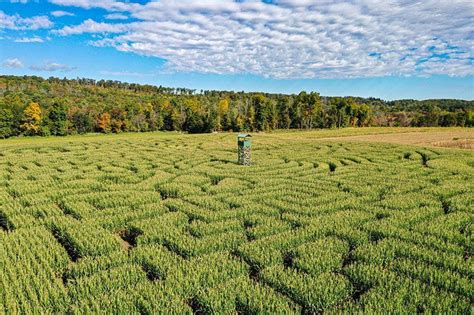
[0,128,474,314]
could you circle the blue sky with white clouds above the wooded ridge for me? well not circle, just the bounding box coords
[0,0,474,100]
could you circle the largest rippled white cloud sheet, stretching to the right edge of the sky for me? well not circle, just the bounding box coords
[51,0,474,78]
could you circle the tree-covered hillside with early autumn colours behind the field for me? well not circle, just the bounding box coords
[0,76,474,138]
